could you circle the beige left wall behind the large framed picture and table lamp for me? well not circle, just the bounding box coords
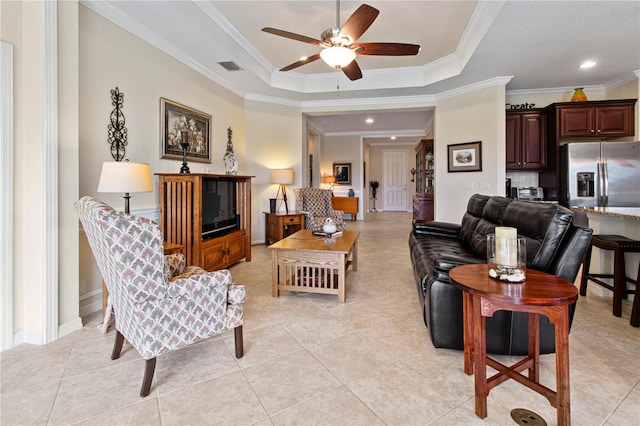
[75,6,250,313]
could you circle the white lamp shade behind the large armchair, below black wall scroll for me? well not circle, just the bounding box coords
[98,161,153,192]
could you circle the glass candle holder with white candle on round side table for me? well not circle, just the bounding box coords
[487,234,527,283]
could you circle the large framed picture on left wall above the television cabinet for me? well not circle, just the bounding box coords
[160,98,211,163]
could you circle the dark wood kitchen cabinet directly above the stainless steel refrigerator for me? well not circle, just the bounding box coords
[556,99,636,138]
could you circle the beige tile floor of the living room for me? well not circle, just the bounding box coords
[0,213,640,425]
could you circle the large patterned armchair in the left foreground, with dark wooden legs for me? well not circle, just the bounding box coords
[76,197,246,397]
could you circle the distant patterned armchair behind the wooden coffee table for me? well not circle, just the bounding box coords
[294,188,344,231]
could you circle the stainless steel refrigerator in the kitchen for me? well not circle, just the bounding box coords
[560,141,640,207]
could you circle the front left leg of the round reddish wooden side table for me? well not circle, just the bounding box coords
[471,296,489,419]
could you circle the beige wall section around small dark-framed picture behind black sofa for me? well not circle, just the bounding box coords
[434,86,505,223]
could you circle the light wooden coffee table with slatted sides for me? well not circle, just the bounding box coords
[269,229,360,303]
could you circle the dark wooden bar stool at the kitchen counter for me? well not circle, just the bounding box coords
[580,234,640,327]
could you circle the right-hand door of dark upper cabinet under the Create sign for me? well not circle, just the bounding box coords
[520,113,547,170]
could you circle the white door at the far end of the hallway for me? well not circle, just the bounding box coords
[382,151,407,212]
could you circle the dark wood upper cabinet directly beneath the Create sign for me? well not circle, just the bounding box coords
[506,109,547,170]
